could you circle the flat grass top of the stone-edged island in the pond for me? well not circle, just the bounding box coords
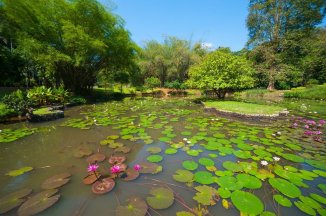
[205,101,283,115]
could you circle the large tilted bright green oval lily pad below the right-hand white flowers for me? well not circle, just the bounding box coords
[268,178,301,198]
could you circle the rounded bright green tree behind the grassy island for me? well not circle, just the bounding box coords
[187,50,254,98]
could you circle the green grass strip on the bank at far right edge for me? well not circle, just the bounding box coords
[284,84,326,100]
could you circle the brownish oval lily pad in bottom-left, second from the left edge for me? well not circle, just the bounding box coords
[18,189,60,216]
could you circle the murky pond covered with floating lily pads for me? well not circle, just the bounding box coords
[0,98,326,216]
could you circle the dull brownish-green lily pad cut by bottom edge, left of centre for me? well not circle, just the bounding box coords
[116,197,148,216]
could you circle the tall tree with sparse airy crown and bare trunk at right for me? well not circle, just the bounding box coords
[247,0,326,90]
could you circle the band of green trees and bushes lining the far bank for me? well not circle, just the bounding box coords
[0,0,326,102]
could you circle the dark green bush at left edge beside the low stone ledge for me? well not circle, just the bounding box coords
[2,90,32,115]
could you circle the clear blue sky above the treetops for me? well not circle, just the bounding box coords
[100,0,324,51]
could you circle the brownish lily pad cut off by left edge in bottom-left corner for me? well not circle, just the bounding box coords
[0,189,32,214]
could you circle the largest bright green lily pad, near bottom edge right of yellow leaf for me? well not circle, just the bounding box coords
[231,191,264,215]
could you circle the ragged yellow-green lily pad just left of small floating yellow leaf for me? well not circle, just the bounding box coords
[193,185,217,205]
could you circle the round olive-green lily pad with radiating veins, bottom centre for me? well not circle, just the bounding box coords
[146,187,174,209]
